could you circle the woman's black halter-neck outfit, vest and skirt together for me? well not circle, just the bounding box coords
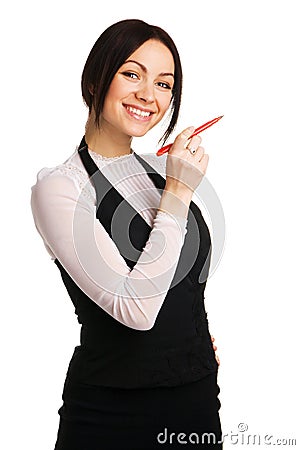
[55,138,222,450]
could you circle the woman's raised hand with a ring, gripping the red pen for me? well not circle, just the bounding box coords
[166,127,209,195]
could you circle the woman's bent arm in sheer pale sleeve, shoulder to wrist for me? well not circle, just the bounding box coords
[31,172,187,330]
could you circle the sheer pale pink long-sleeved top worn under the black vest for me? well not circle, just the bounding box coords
[31,148,187,330]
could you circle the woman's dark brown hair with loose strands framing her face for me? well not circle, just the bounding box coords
[81,19,182,143]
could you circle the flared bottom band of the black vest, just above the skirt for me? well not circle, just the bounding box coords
[68,330,217,388]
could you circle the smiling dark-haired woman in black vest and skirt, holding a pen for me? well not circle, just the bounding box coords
[32,20,221,450]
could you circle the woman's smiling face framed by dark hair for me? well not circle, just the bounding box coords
[100,39,175,137]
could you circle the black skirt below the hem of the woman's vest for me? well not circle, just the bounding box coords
[55,372,222,450]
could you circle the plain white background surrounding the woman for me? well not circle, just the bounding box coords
[0,0,300,450]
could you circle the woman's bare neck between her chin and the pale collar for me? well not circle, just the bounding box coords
[85,113,132,158]
